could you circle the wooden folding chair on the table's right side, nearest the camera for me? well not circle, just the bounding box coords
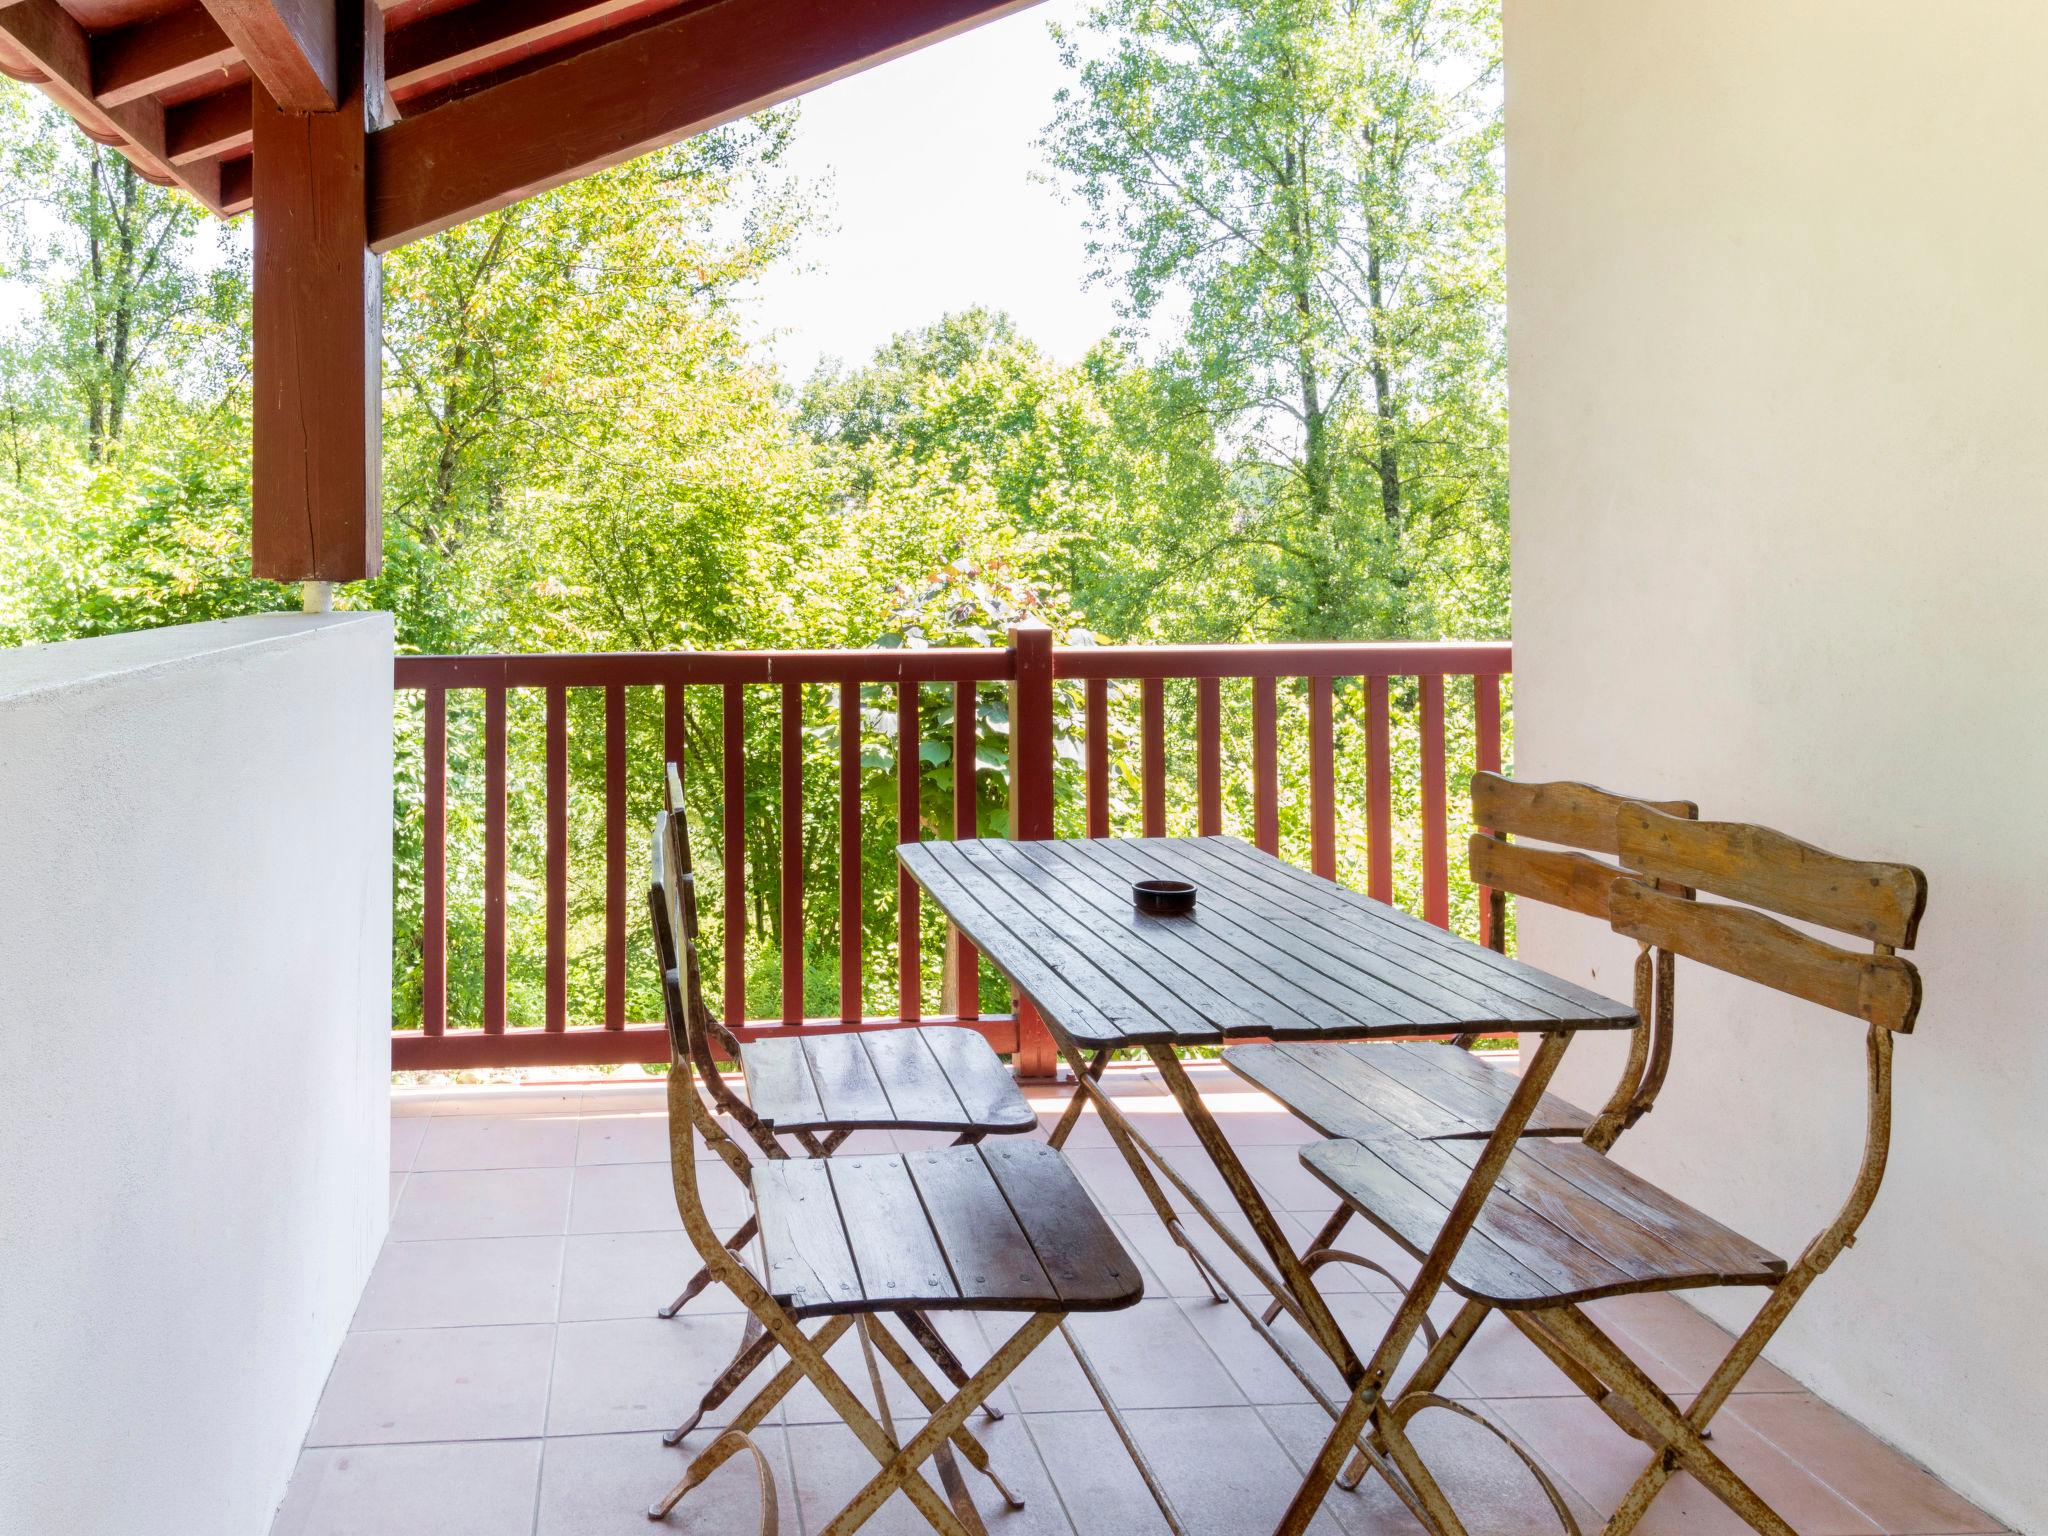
[1280,805,1927,1536]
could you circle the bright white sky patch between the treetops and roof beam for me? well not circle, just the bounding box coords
[756,0,1116,383]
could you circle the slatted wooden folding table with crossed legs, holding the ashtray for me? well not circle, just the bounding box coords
[897,838,1636,1531]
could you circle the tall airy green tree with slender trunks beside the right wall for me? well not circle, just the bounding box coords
[1047,0,1505,637]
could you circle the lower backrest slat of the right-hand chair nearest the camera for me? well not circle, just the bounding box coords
[1610,874,1921,1034]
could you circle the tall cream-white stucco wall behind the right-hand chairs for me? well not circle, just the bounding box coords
[1507,0,2048,1530]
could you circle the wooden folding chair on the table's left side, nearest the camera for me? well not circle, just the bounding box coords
[647,815,1143,1536]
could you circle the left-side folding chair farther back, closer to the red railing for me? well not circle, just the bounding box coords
[659,762,1038,1446]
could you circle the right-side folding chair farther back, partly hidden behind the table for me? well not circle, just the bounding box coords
[1223,772,1700,1310]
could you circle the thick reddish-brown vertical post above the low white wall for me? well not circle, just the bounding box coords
[250,0,385,582]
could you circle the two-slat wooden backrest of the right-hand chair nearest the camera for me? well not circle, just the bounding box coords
[1610,805,1927,1032]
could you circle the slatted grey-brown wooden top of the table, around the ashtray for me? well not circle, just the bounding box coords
[897,838,1636,1056]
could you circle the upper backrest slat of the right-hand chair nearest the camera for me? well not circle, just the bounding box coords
[1618,805,1927,948]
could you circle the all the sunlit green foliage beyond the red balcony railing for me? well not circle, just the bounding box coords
[0,0,1507,1040]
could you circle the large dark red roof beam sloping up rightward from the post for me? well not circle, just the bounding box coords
[364,0,1034,252]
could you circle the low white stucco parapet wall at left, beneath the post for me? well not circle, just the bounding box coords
[0,614,391,1536]
